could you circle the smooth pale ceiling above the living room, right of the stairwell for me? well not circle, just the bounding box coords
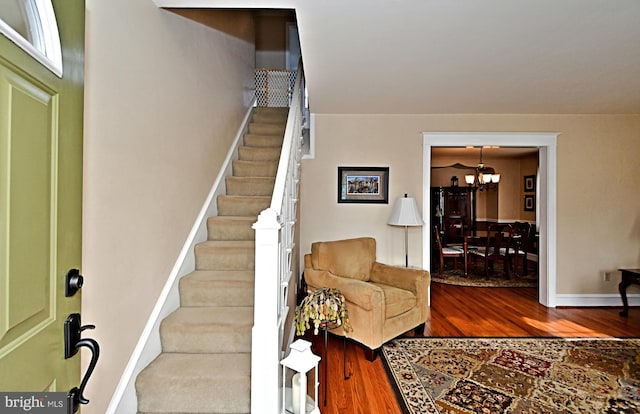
[155,0,640,114]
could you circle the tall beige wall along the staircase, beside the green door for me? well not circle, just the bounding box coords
[82,0,254,414]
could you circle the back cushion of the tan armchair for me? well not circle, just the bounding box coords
[311,237,376,282]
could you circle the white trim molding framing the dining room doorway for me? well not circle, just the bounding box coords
[422,132,559,307]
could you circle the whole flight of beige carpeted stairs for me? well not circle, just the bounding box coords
[136,108,288,414]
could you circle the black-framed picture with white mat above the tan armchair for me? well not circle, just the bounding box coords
[338,167,389,204]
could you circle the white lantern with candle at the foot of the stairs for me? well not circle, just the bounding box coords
[280,339,320,414]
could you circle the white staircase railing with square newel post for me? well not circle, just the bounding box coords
[251,64,305,414]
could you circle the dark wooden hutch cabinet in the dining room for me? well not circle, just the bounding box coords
[431,186,476,244]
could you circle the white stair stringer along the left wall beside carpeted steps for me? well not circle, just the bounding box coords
[106,102,255,414]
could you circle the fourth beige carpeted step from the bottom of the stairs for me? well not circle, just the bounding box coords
[195,240,255,270]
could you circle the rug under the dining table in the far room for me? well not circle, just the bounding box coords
[431,263,538,287]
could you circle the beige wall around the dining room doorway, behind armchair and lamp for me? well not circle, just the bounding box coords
[300,114,640,294]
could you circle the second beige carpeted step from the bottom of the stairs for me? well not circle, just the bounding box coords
[160,306,253,354]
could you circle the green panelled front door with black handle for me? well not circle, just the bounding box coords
[0,0,84,402]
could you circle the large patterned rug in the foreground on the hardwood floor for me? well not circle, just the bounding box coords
[382,338,640,414]
